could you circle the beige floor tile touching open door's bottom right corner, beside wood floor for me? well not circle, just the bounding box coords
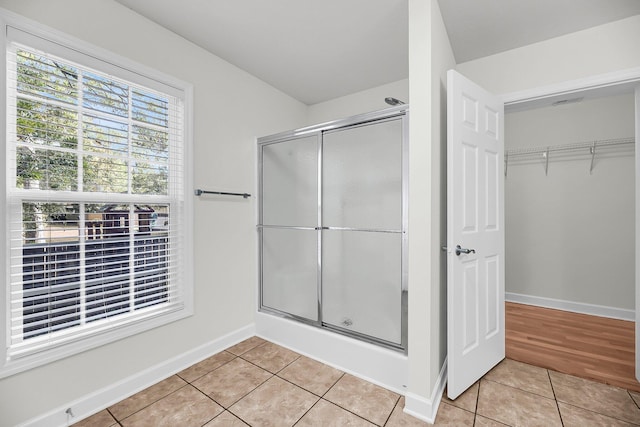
[483,359,555,399]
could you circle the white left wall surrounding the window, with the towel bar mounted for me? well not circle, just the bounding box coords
[0,0,307,425]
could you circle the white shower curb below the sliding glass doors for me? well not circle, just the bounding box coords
[255,312,409,395]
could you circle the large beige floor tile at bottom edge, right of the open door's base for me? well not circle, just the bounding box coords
[477,379,562,427]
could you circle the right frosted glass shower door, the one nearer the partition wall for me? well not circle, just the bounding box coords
[322,118,403,346]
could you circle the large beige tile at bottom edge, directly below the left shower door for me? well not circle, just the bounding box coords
[229,376,319,427]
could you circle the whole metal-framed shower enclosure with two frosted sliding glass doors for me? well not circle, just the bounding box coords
[258,105,407,350]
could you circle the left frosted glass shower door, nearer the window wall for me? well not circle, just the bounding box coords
[260,135,319,322]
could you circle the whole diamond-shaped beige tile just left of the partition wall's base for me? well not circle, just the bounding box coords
[324,374,400,425]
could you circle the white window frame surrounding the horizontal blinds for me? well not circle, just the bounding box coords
[0,9,194,378]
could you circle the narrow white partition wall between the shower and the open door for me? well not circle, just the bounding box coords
[405,0,455,421]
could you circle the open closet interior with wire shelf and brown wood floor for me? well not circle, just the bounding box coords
[505,92,640,390]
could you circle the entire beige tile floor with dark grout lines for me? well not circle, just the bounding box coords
[76,337,640,427]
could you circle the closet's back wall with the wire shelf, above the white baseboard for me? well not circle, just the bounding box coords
[505,93,635,310]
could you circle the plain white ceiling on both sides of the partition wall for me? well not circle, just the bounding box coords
[116,0,640,105]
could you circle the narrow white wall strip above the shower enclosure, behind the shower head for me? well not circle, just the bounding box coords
[307,79,409,125]
